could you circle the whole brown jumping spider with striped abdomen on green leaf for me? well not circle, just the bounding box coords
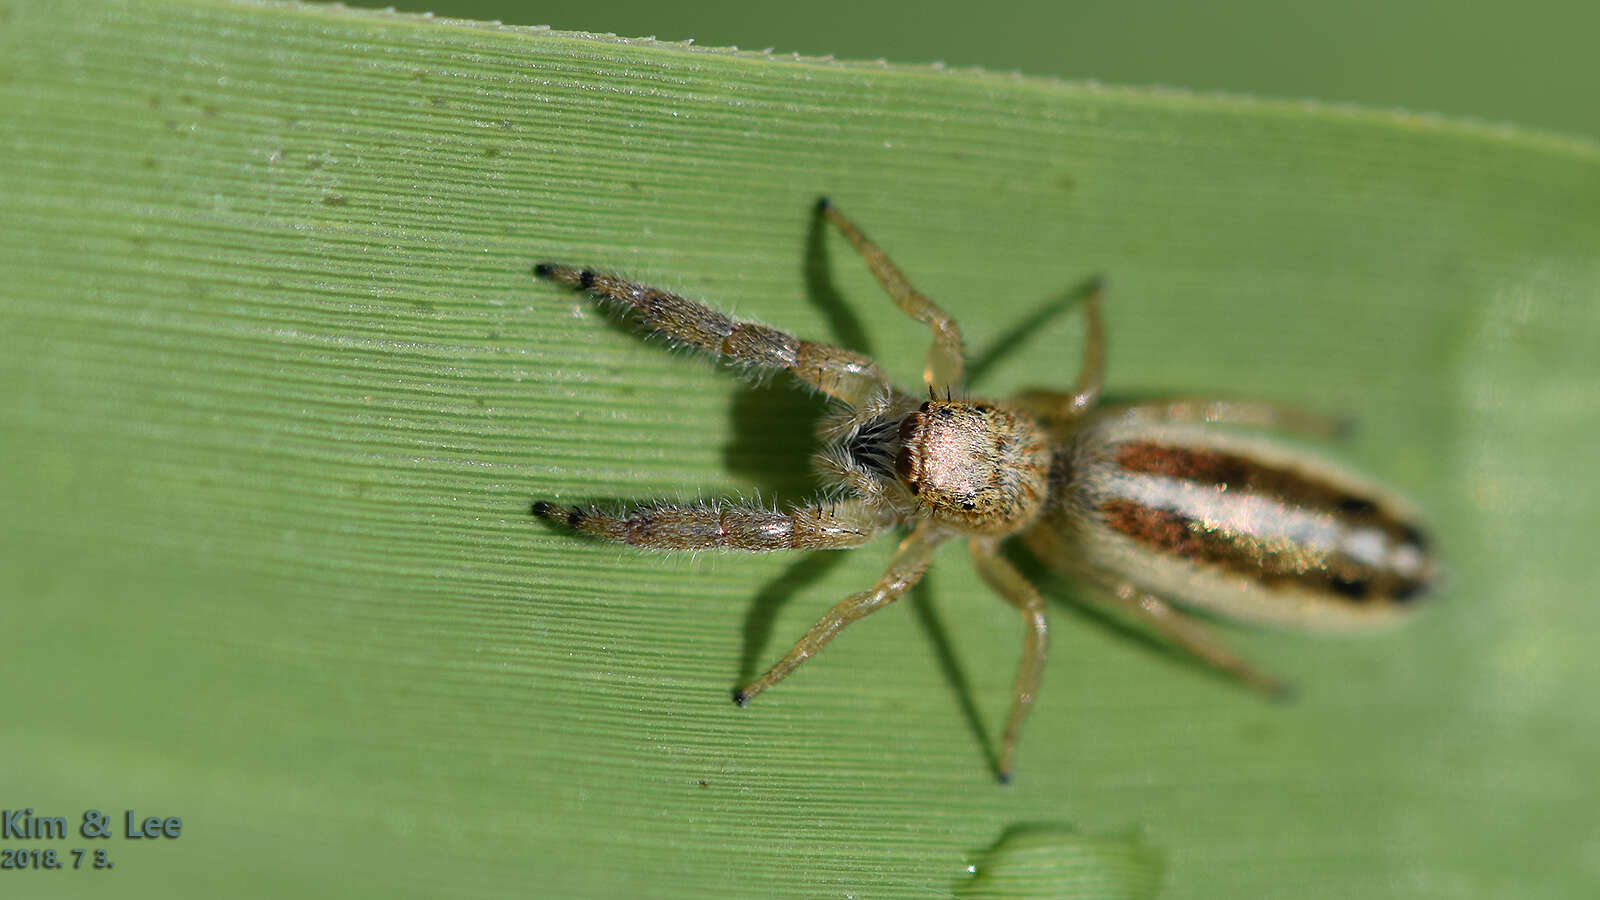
[533,200,1435,780]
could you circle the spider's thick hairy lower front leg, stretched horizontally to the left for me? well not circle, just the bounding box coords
[533,500,883,552]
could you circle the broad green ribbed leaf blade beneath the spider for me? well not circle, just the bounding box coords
[0,2,1600,897]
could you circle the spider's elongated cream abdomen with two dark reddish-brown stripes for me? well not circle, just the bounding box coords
[1030,424,1435,628]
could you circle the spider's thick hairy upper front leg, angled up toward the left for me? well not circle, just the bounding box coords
[533,263,890,398]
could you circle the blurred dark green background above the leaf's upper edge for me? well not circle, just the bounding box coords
[357,0,1600,136]
